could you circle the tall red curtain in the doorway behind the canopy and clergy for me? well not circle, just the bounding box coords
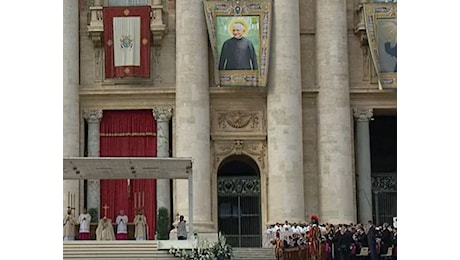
[100,110,157,239]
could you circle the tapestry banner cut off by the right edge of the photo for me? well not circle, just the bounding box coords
[364,3,397,89]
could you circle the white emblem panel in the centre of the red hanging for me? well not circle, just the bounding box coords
[113,17,141,67]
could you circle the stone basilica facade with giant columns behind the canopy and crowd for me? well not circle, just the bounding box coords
[63,0,397,247]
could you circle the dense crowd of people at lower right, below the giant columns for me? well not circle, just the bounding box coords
[266,216,397,260]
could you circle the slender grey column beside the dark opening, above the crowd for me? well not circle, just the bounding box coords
[353,109,373,223]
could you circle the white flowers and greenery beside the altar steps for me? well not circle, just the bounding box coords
[169,232,233,260]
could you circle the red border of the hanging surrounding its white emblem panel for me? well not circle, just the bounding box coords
[103,6,150,78]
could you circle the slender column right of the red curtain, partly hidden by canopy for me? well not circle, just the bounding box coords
[153,108,172,219]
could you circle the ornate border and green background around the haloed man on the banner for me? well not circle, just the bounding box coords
[204,0,272,87]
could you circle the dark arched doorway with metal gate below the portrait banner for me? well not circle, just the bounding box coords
[217,155,262,247]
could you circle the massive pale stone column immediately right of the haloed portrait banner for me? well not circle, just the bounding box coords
[267,0,305,223]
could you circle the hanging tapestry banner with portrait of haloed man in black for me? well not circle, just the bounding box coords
[204,0,272,87]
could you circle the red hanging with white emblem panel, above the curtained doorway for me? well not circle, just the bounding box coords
[103,6,150,78]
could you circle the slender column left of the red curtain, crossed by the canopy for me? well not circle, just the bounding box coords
[83,110,102,219]
